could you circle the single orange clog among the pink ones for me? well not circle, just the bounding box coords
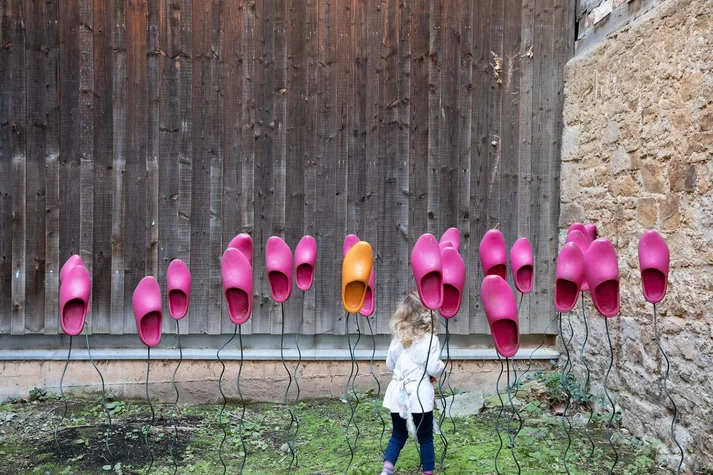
[342,241,374,313]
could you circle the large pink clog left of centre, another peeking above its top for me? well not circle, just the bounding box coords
[225,248,253,325]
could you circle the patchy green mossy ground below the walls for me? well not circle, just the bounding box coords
[0,386,667,475]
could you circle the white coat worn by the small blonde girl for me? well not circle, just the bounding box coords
[383,334,445,414]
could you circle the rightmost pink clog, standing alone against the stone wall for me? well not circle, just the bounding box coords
[639,230,671,303]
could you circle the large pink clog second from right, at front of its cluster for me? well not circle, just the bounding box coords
[584,239,619,318]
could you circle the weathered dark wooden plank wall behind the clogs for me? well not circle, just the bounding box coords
[0,0,574,334]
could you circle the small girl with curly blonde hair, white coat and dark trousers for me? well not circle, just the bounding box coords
[381,292,445,475]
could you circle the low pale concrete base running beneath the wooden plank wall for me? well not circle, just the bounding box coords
[0,360,548,403]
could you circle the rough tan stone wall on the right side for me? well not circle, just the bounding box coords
[560,0,713,470]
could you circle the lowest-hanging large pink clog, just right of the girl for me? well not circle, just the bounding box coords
[480,275,520,358]
